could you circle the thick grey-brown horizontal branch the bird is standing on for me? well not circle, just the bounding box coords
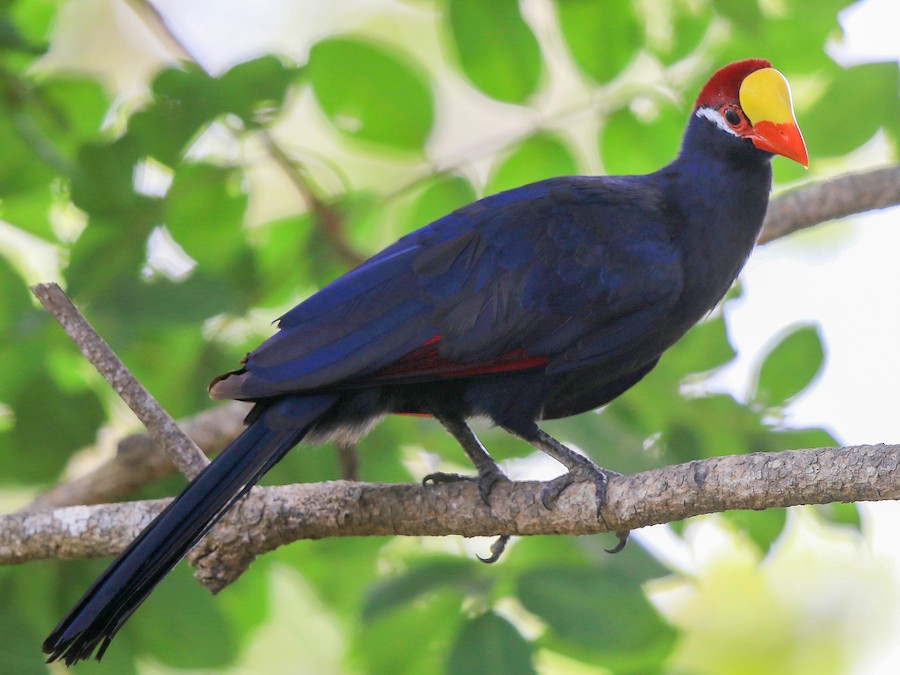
[0,445,900,590]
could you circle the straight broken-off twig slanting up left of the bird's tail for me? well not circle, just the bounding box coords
[31,284,209,478]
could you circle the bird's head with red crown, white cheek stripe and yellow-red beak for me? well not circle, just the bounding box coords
[694,59,809,167]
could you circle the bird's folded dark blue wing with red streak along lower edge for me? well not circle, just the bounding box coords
[212,177,681,398]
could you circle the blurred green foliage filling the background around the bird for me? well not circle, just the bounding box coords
[0,0,900,674]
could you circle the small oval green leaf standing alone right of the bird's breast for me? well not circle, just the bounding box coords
[751,325,825,407]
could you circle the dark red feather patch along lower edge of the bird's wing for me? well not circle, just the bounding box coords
[366,335,550,380]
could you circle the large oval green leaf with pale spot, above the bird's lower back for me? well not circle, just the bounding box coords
[308,38,434,151]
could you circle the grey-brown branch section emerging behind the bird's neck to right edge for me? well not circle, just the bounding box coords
[759,165,900,244]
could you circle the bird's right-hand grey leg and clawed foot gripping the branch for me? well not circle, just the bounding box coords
[509,424,628,553]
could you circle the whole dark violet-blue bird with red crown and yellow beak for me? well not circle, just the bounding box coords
[44,59,807,664]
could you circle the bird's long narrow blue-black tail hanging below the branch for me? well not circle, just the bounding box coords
[43,394,337,665]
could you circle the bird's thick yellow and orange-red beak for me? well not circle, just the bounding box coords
[740,68,809,167]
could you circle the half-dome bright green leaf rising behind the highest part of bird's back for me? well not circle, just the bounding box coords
[485,133,578,194]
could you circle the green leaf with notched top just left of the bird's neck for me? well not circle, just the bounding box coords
[600,103,685,174]
